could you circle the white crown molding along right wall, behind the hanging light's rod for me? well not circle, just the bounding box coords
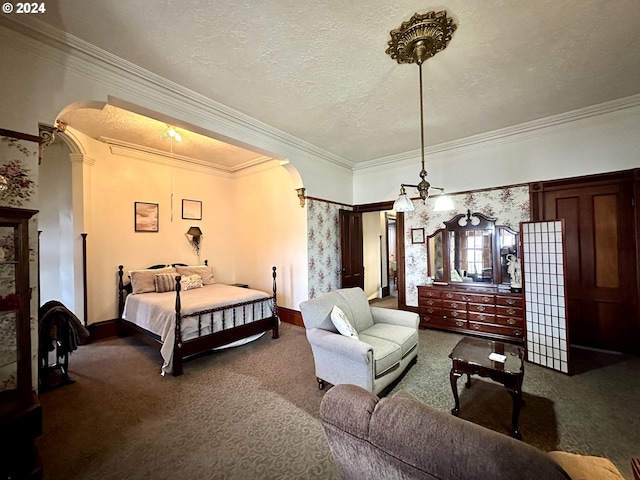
[353,95,640,171]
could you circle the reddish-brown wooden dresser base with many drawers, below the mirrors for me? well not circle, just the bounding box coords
[418,284,525,342]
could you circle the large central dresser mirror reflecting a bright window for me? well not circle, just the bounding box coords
[449,230,493,283]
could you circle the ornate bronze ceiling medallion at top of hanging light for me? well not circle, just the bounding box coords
[386,10,457,64]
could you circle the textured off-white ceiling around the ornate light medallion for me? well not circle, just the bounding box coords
[39,0,640,169]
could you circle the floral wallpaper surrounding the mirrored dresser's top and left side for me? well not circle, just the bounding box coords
[404,185,530,307]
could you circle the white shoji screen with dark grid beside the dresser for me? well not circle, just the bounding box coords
[520,220,570,373]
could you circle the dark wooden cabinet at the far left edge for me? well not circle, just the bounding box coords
[0,207,42,479]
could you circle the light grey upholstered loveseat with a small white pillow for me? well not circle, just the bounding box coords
[300,288,419,394]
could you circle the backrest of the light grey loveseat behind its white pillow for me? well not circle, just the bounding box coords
[300,287,373,333]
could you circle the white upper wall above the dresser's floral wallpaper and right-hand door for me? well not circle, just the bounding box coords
[353,102,640,204]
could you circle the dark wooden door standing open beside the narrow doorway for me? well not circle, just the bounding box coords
[339,210,364,290]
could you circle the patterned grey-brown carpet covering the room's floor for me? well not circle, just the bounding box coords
[36,324,640,480]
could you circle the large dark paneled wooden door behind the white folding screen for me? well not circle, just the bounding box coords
[533,175,640,352]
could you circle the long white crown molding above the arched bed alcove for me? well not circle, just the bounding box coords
[0,15,354,170]
